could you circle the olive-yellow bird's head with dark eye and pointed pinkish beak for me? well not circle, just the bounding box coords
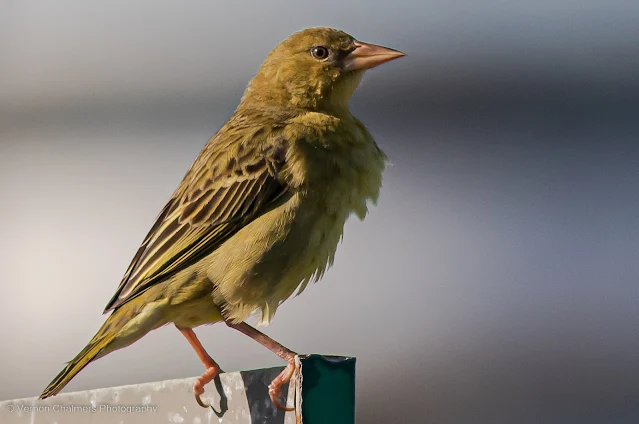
[240,28,405,115]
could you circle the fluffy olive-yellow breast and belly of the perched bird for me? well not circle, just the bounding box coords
[208,116,385,323]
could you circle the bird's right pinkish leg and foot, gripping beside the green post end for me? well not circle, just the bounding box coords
[224,319,297,411]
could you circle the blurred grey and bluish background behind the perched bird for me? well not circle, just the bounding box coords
[0,0,639,424]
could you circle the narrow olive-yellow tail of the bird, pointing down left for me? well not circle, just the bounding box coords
[40,304,156,399]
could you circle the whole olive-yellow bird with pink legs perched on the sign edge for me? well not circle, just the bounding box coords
[40,27,405,410]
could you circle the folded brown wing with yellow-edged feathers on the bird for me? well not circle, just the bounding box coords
[105,132,287,312]
